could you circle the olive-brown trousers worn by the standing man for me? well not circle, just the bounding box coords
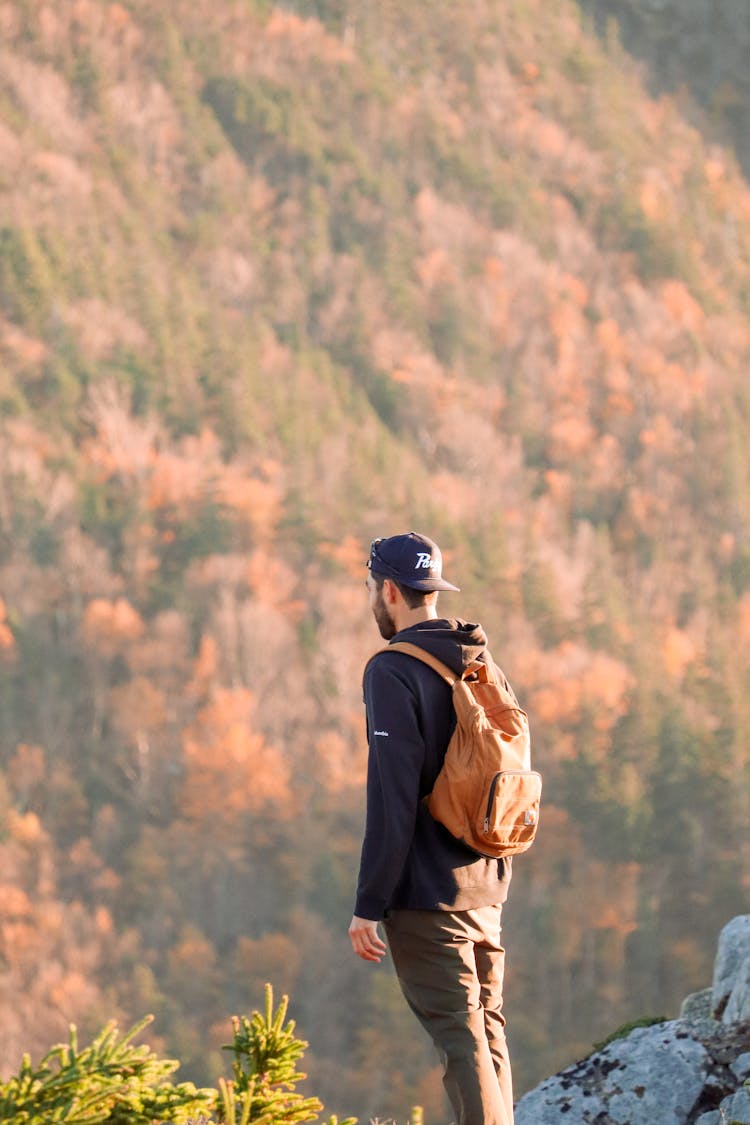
[383,906,513,1125]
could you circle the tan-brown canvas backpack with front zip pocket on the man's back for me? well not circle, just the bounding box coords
[373,641,542,860]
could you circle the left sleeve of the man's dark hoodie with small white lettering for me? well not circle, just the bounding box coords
[354,655,425,920]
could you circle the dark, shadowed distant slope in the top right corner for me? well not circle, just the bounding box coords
[580,0,750,172]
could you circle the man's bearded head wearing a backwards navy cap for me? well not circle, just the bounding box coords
[367,531,459,640]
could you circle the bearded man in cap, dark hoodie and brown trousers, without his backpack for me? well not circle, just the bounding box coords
[349,532,513,1125]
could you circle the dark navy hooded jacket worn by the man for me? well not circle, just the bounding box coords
[354,619,510,920]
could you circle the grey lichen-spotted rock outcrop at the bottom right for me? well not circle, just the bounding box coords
[516,915,750,1125]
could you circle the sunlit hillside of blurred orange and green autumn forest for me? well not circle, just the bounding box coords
[0,0,750,1122]
